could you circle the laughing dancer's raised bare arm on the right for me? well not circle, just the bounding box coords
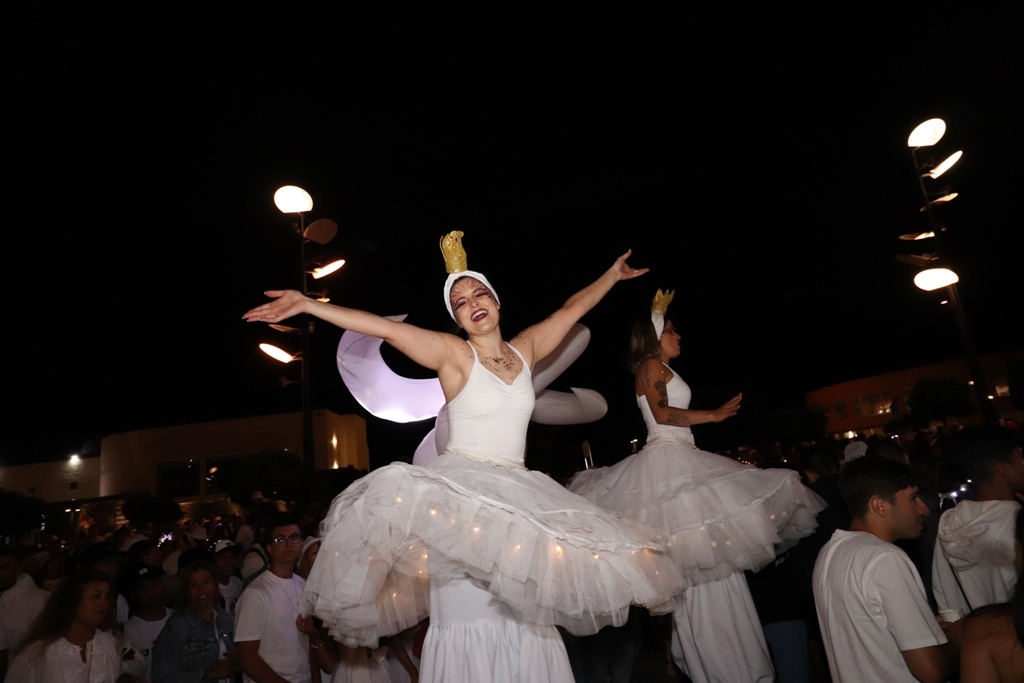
[512,249,647,368]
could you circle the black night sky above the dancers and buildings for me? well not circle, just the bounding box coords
[0,9,1024,471]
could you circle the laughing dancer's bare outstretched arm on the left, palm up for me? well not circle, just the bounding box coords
[242,290,464,375]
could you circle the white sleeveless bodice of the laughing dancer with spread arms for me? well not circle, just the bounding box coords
[445,342,536,465]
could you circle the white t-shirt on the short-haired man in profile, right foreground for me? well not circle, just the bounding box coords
[814,529,946,683]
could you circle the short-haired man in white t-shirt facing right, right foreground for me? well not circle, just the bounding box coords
[814,457,963,683]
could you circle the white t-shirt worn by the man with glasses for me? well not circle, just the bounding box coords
[234,569,311,683]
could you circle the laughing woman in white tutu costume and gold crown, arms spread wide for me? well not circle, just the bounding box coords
[245,231,682,683]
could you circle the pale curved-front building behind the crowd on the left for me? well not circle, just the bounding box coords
[0,411,370,503]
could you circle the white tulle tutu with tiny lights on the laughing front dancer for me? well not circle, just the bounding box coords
[304,454,683,647]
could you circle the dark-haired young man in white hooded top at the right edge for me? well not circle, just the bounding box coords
[932,424,1024,613]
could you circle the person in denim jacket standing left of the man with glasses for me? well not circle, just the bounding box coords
[153,561,238,683]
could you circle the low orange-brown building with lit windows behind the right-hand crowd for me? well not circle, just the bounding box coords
[807,351,1024,434]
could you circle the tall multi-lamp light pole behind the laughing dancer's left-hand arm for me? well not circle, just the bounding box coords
[260,185,345,492]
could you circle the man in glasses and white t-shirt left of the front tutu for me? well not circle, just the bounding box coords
[234,518,323,683]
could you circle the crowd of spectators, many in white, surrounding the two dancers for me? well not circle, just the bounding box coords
[0,425,1024,683]
